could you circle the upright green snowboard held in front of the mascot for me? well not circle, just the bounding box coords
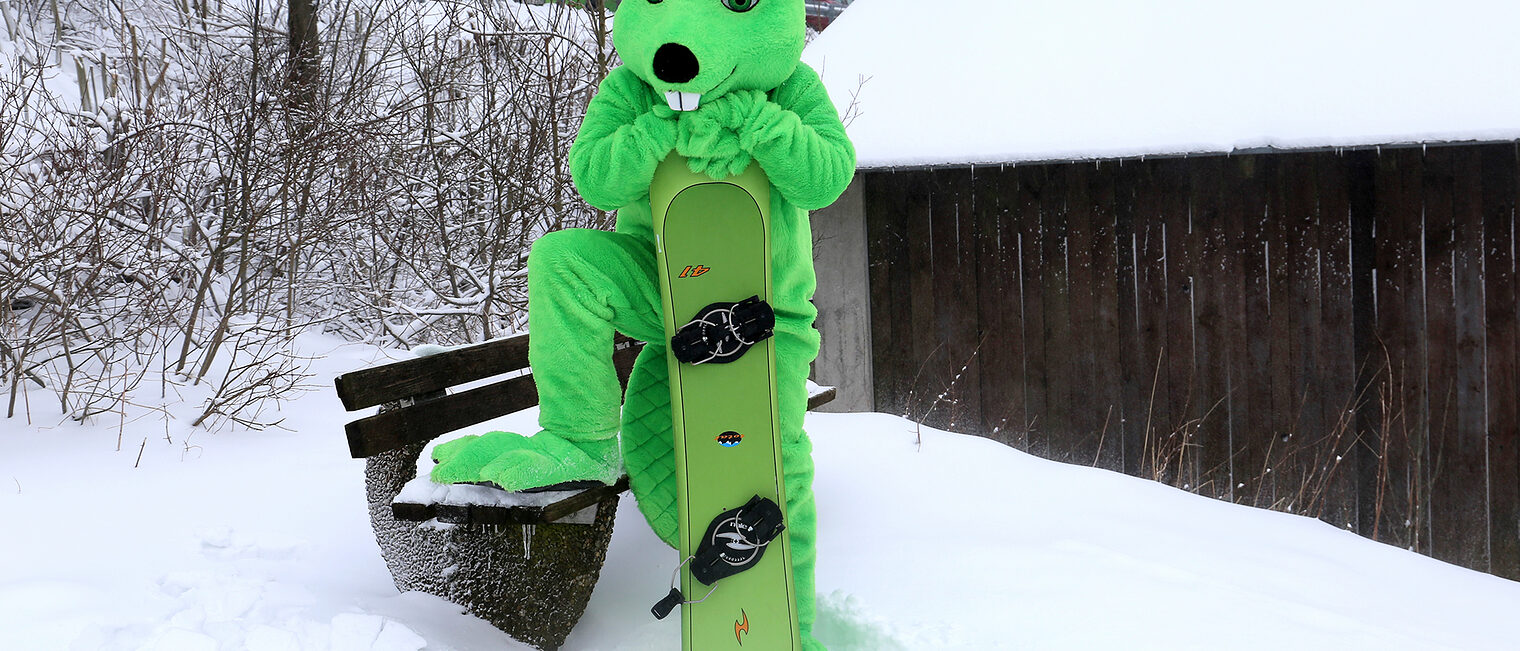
[651,154,801,651]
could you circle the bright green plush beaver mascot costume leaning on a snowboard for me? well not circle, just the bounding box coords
[433,0,854,649]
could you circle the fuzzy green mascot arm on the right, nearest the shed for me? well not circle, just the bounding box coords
[739,64,856,210]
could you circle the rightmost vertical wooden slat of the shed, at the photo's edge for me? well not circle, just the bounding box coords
[1482,144,1520,580]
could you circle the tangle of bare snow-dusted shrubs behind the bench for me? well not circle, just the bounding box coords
[0,0,613,429]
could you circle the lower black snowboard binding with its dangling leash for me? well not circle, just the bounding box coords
[651,496,786,619]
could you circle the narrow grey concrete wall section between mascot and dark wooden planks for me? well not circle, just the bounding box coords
[813,175,876,412]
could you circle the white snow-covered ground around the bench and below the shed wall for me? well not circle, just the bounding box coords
[0,338,1520,651]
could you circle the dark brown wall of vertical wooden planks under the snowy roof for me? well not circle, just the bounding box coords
[865,143,1520,578]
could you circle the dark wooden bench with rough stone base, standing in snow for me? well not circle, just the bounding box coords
[336,335,834,649]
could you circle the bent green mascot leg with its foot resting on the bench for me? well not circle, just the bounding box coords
[433,230,664,491]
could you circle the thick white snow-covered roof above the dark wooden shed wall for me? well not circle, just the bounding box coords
[803,0,1520,167]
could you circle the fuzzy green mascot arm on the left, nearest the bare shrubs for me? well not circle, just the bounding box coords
[570,67,676,210]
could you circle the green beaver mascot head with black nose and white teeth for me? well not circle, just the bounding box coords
[613,0,806,111]
